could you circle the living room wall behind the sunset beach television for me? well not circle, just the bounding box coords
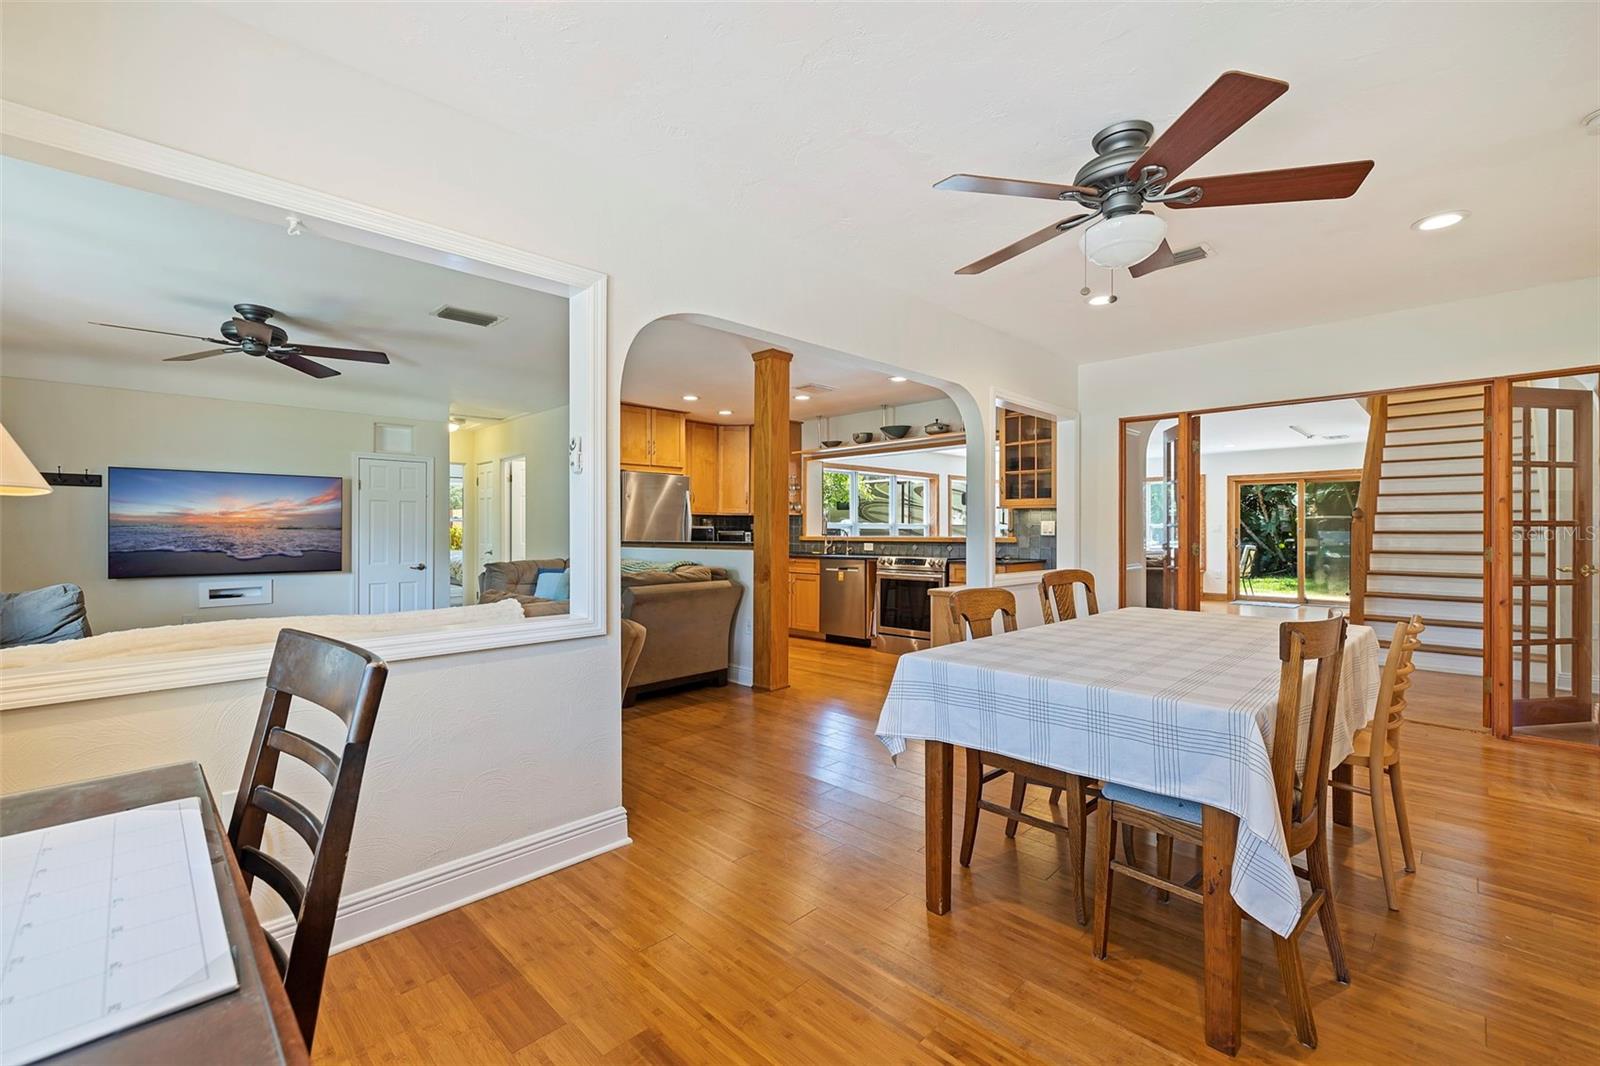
[0,378,450,632]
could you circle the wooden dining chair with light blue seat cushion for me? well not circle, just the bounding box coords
[1094,615,1350,1047]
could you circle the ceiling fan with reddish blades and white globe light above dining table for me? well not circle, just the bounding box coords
[934,70,1373,277]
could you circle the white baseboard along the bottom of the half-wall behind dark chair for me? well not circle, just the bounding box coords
[264,807,632,952]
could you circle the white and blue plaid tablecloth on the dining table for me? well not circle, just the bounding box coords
[878,607,1379,935]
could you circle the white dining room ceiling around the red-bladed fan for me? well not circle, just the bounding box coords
[219,3,1600,360]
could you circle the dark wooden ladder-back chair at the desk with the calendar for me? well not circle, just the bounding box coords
[227,629,389,1050]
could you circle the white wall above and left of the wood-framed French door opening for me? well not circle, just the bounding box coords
[1078,279,1600,602]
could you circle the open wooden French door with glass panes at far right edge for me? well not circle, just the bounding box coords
[1507,386,1595,730]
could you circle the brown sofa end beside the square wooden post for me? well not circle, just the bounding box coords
[622,565,744,706]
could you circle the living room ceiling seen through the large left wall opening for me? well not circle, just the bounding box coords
[0,158,568,418]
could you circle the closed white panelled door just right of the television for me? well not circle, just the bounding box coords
[355,458,434,615]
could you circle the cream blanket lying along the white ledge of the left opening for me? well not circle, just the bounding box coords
[0,600,525,669]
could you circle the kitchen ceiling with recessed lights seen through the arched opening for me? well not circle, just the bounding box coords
[622,319,944,424]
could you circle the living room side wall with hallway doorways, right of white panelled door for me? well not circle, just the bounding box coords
[450,407,571,592]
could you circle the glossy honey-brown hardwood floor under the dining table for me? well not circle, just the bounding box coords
[315,640,1600,1066]
